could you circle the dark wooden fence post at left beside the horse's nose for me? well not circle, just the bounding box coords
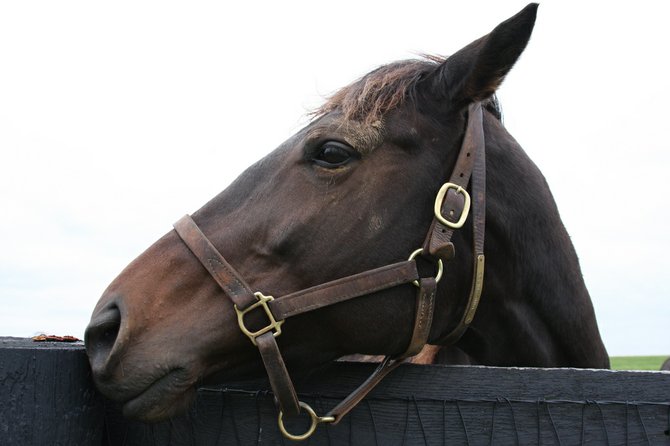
[0,338,105,446]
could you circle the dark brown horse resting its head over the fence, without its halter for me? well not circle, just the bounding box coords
[86,5,609,428]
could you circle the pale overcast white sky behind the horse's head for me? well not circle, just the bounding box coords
[0,0,670,355]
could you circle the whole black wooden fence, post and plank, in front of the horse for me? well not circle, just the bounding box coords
[0,338,670,446]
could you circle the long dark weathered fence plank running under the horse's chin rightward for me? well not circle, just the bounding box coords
[103,363,670,445]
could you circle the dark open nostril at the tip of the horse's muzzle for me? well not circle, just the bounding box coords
[85,305,121,371]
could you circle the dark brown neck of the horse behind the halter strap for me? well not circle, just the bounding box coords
[448,116,608,367]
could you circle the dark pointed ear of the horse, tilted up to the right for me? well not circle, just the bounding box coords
[423,3,538,110]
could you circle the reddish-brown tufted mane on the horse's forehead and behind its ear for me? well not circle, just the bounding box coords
[312,55,502,124]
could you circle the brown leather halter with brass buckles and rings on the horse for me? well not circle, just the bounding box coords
[174,103,486,440]
